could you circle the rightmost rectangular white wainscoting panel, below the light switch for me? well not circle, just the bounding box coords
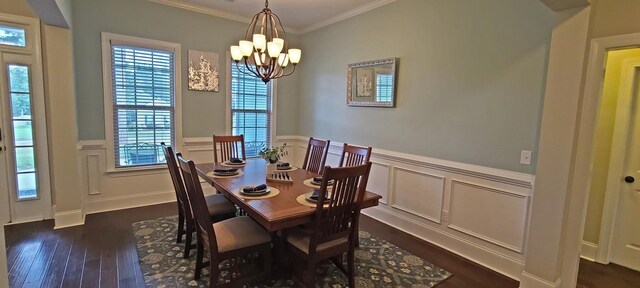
[449,180,529,253]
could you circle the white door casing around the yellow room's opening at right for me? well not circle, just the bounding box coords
[561,33,640,287]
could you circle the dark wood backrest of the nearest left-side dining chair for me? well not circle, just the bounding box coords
[177,153,218,253]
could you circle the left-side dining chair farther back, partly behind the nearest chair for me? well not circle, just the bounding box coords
[160,142,236,259]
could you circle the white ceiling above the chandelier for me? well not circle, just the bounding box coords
[149,0,396,34]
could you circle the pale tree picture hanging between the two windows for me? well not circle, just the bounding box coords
[189,50,220,92]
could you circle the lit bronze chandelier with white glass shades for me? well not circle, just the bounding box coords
[231,0,302,83]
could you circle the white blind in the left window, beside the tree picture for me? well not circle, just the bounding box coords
[111,43,175,168]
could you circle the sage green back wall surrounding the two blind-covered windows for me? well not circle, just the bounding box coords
[72,0,298,140]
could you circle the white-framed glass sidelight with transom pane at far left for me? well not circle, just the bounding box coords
[0,16,52,223]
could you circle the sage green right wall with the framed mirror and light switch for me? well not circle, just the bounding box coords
[299,0,554,173]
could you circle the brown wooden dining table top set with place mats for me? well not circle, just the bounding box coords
[196,159,382,232]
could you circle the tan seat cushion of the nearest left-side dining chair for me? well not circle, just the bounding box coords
[213,216,271,253]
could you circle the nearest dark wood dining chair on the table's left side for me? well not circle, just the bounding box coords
[178,155,271,287]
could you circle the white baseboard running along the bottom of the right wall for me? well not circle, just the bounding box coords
[362,206,524,280]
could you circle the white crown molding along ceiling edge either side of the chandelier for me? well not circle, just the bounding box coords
[148,0,396,35]
